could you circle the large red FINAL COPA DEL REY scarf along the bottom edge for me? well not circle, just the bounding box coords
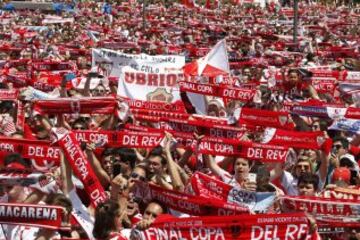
[139,213,309,240]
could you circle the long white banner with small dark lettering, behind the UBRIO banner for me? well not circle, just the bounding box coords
[92,48,185,77]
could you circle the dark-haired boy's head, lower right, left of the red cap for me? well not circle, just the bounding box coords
[298,172,319,197]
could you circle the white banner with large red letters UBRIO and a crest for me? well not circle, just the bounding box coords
[117,67,183,103]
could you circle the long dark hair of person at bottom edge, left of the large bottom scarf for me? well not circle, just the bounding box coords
[93,200,120,239]
